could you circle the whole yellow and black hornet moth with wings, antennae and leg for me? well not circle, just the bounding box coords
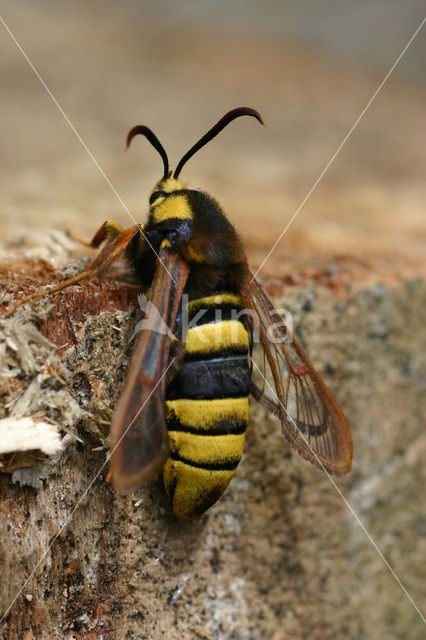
[9,107,352,519]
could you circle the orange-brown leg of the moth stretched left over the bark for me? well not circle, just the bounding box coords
[5,221,141,318]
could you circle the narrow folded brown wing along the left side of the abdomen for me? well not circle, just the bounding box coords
[110,249,188,491]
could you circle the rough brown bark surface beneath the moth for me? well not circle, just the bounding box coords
[0,242,426,640]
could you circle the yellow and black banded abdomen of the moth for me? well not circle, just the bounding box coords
[163,293,250,520]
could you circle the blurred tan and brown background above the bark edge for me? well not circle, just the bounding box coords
[0,0,426,278]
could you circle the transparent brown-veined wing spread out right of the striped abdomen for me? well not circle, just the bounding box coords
[242,274,352,475]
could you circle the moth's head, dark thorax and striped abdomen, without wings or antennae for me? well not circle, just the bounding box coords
[113,156,250,519]
